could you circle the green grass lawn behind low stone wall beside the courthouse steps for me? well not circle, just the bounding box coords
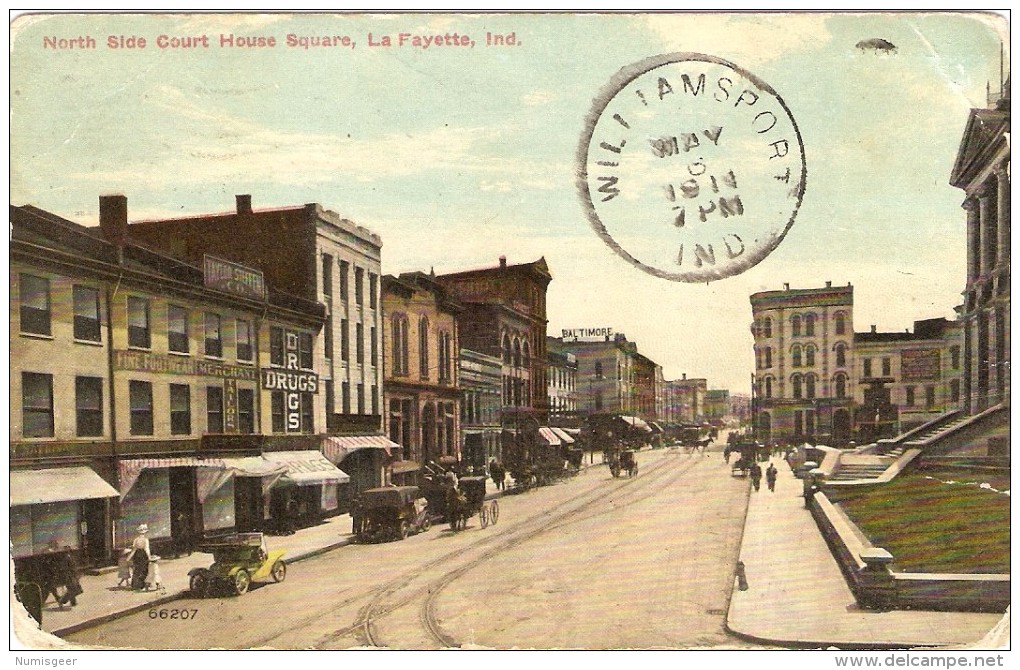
[832,470,1010,573]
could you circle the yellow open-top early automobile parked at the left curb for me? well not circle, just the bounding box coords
[188,532,287,598]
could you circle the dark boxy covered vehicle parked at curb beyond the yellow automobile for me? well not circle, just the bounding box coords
[355,486,432,542]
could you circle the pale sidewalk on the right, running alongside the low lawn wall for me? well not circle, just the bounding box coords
[726,458,1009,649]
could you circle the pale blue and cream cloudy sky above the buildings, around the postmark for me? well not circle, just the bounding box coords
[10,13,1009,393]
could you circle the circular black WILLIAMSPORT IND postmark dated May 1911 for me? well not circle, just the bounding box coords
[577,53,807,282]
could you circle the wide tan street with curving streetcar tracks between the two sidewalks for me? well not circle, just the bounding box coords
[67,450,749,650]
